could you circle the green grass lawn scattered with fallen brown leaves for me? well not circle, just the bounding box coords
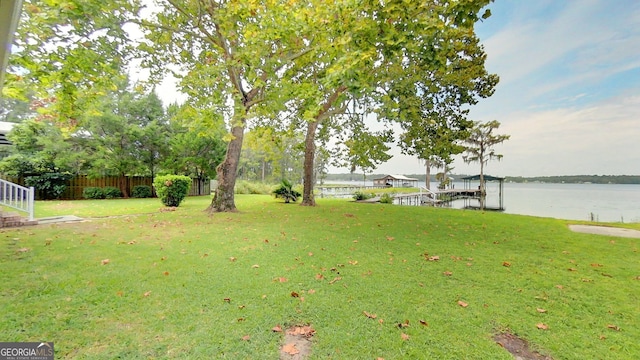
[0,195,640,360]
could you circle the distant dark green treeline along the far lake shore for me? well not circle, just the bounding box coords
[324,173,640,184]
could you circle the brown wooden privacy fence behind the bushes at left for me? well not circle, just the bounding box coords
[4,175,211,200]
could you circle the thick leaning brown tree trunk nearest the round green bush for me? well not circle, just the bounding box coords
[207,119,246,212]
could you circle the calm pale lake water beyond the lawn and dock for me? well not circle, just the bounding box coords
[322,181,640,222]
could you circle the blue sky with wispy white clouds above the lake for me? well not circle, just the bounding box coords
[158,0,640,176]
